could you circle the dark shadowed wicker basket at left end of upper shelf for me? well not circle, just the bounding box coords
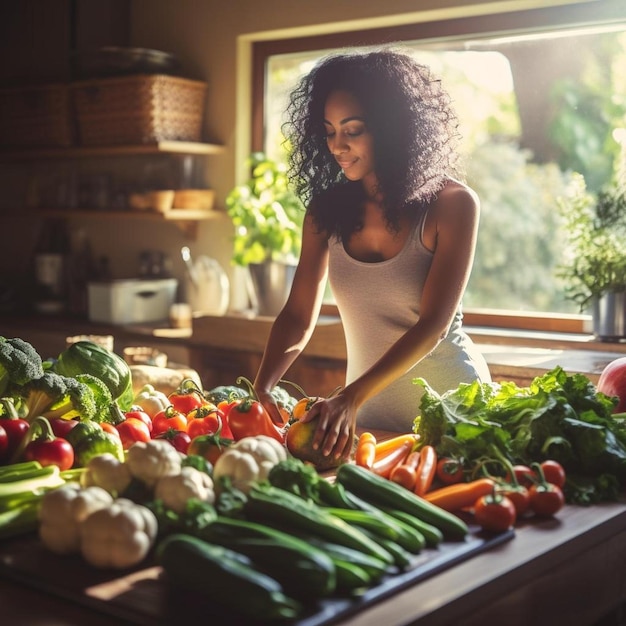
[0,84,74,148]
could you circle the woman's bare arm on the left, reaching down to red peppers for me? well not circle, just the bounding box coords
[254,215,328,423]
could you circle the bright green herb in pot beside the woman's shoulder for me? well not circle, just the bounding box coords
[226,152,304,316]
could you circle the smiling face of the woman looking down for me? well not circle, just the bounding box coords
[324,91,376,183]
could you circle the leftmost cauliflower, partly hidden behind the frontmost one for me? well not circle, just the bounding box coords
[39,483,113,554]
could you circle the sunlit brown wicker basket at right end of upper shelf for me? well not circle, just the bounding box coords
[71,74,207,146]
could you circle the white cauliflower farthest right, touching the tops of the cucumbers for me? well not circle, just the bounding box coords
[213,435,287,493]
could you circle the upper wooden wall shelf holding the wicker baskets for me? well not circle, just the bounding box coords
[0,141,224,160]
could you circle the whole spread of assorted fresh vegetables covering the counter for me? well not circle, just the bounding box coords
[0,337,626,623]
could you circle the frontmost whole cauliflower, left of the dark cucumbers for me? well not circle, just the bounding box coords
[80,494,157,569]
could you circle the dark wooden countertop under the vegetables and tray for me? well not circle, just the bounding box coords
[0,504,626,626]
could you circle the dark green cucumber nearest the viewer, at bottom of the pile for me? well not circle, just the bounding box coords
[156,533,303,620]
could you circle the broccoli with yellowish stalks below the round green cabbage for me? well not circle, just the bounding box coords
[19,371,97,421]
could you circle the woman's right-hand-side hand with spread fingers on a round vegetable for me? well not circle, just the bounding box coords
[301,392,356,459]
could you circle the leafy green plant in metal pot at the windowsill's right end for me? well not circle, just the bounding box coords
[559,169,626,340]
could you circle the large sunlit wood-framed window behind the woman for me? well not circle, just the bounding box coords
[249,2,626,332]
